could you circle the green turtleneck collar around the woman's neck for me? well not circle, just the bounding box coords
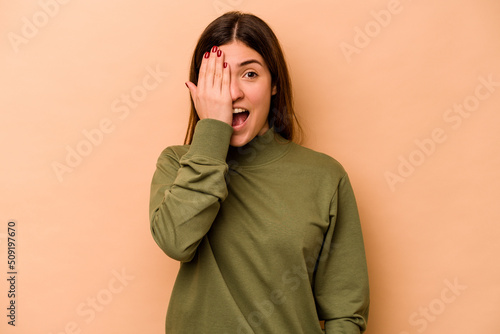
[226,128,290,168]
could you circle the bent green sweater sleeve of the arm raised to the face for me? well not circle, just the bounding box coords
[149,119,233,262]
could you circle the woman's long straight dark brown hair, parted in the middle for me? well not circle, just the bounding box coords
[184,12,301,144]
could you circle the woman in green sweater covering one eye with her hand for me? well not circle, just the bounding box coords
[150,12,369,334]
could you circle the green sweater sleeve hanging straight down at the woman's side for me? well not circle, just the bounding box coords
[314,175,369,334]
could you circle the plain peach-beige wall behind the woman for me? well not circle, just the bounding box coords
[0,0,500,334]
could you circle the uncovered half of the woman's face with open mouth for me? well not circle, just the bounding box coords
[219,41,276,147]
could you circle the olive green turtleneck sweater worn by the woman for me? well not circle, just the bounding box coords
[150,119,369,334]
